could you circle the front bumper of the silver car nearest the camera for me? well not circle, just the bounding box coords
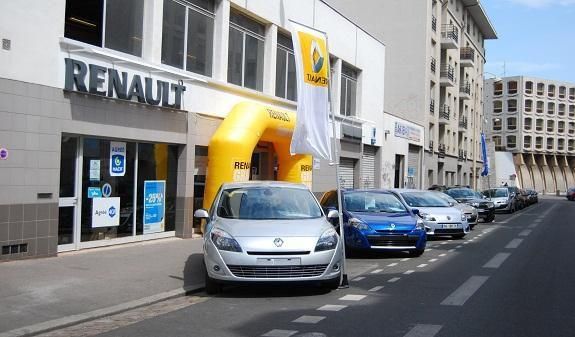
[204,240,343,283]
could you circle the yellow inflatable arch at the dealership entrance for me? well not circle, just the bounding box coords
[204,102,312,209]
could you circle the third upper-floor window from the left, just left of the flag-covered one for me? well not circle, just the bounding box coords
[228,10,265,91]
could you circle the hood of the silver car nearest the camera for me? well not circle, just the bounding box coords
[214,217,333,238]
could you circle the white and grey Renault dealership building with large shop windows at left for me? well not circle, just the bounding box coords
[0,0,385,261]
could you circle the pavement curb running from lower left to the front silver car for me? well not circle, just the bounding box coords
[0,284,204,337]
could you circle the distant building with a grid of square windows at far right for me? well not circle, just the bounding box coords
[485,76,575,193]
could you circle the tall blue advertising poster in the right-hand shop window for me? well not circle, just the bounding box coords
[144,180,166,234]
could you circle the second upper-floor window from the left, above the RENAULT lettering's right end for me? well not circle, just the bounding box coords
[162,0,215,76]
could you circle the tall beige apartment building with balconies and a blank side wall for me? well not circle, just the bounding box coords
[329,0,497,187]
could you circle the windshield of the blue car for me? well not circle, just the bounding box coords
[344,192,407,213]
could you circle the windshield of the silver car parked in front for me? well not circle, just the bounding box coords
[217,186,322,220]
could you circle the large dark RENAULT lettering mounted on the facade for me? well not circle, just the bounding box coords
[64,58,186,109]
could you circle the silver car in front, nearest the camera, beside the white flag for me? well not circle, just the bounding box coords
[194,181,343,294]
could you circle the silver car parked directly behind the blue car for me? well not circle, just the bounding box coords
[391,189,469,239]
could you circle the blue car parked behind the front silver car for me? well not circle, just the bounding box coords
[320,189,427,256]
